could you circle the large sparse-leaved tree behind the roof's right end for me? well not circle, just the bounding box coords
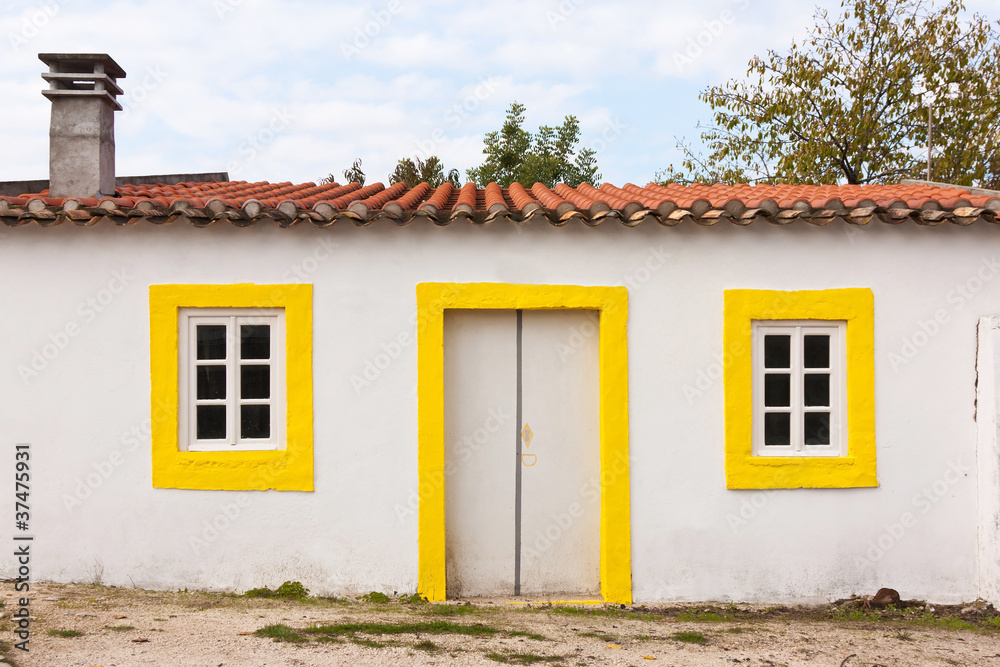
[657,0,1000,187]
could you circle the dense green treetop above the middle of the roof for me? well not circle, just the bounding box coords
[465,102,601,187]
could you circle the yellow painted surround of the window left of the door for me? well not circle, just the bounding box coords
[149,284,313,491]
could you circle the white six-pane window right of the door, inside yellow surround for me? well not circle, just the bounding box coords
[751,320,847,456]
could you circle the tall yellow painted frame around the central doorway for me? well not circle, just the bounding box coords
[417,283,632,604]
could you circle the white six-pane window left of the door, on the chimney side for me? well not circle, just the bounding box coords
[178,308,285,452]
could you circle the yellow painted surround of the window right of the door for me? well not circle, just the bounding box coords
[723,288,878,489]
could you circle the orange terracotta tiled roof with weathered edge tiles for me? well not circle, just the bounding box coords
[0,181,1000,227]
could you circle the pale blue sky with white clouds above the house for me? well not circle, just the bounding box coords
[0,0,995,185]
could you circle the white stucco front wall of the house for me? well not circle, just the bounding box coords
[0,222,1000,602]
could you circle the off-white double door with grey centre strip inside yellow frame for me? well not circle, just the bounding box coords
[444,310,600,596]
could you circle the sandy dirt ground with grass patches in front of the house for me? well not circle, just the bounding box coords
[0,584,1000,667]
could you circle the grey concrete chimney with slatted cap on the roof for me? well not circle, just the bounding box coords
[38,53,125,197]
